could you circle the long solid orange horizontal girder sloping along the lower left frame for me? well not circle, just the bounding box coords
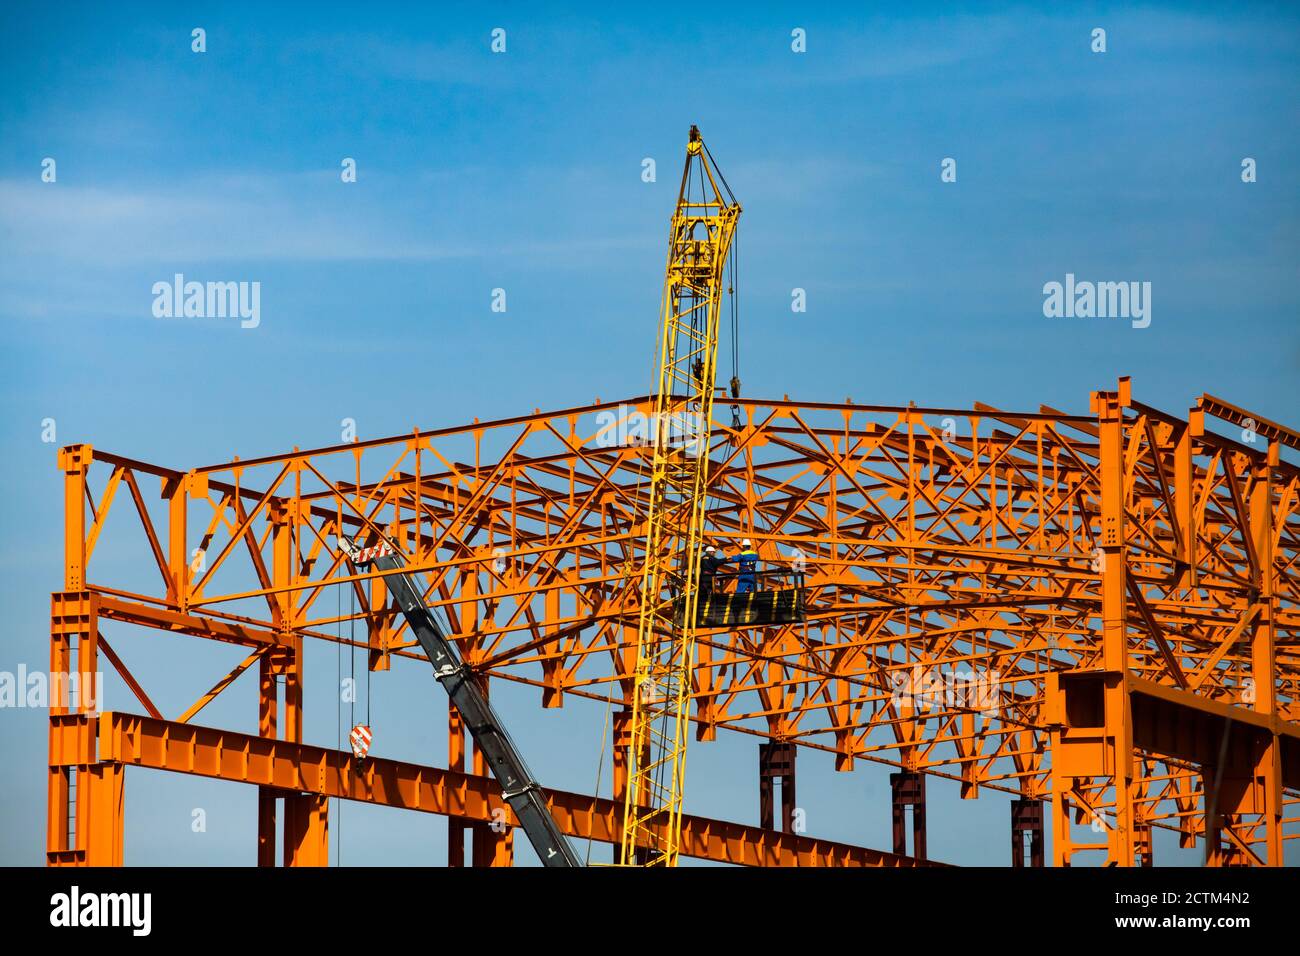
[53,711,939,866]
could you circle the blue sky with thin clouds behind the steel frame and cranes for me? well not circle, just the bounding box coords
[0,3,1300,864]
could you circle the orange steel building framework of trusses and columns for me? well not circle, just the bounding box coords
[48,378,1300,866]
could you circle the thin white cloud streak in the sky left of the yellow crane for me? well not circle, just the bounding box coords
[0,173,645,267]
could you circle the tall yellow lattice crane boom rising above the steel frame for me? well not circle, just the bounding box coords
[620,126,741,866]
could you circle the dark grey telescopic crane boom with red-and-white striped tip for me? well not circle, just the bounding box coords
[338,535,582,866]
